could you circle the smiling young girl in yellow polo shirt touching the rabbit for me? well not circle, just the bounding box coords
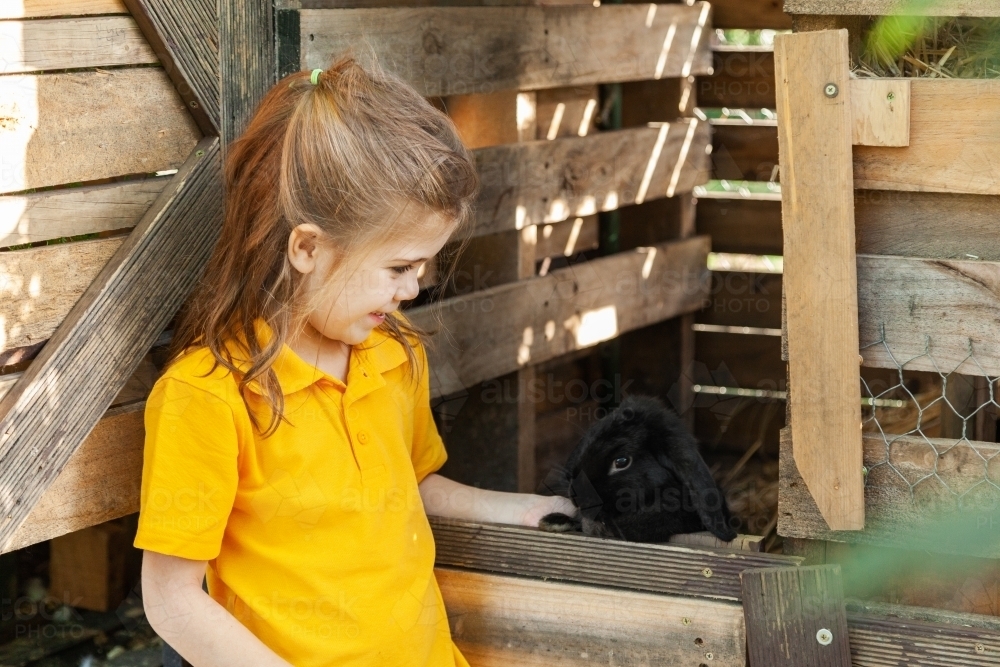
[135,59,573,667]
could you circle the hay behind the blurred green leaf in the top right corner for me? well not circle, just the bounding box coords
[853,16,1000,79]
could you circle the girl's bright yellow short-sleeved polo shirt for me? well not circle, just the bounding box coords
[135,330,468,667]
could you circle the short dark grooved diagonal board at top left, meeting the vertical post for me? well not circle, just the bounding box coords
[124,0,220,136]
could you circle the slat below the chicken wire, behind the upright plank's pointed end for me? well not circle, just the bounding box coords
[778,428,1000,558]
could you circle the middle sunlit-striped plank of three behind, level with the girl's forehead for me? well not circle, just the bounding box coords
[472,119,711,235]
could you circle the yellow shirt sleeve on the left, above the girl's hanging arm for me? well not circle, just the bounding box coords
[135,376,239,560]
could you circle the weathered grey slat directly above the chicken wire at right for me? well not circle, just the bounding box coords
[857,255,1000,377]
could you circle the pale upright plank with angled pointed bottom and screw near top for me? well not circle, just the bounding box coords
[775,30,864,530]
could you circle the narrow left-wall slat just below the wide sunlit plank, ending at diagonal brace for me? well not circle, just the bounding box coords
[0,177,170,248]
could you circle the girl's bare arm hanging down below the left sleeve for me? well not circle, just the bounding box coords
[142,551,291,667]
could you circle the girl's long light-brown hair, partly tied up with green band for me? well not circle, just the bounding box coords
[170,56,479,435]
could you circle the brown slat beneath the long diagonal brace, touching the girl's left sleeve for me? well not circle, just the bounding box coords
[6,402,146,551]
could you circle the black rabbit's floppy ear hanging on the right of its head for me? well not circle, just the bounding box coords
[657,431,736,542]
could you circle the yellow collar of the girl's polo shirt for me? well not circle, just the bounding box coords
[233,319,406,400]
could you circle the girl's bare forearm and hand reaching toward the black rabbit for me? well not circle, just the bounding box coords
[420,474,577,526]
